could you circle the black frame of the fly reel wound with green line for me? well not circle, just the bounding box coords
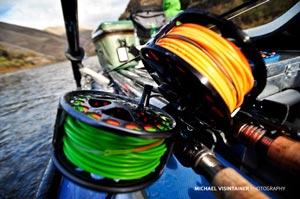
[51,91,175,193]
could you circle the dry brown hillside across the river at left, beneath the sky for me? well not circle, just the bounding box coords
[0,22,94,72]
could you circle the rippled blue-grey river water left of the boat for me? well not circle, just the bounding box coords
[0,57,98,199]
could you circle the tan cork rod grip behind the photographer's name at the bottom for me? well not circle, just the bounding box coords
[212,168,269,199]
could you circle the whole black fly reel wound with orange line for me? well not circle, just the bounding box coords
[141,9,266,129]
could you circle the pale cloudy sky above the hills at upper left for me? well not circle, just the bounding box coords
[0,0,129,30]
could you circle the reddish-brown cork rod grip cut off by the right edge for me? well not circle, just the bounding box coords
[267,136,300,175]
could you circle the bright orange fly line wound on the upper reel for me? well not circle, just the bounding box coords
[157,23,254,113]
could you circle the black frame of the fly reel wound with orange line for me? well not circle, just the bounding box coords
[141,9,266,129]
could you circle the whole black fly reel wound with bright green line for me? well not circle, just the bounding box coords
[52,87,175,193]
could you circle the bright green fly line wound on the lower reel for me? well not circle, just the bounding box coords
[63,116,167,180]
